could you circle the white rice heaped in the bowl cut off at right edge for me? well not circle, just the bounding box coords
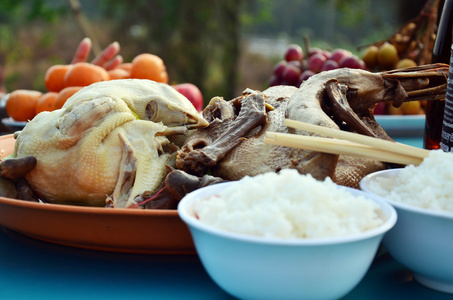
[369,150,453,212]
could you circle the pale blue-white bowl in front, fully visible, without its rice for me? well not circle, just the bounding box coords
[178,182,397,299]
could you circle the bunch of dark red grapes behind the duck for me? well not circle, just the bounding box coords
[269,44,365,87]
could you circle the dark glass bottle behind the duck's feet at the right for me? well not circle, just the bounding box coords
[423,0,453,149]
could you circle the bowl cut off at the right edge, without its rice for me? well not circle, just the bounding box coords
[360,169,453,293]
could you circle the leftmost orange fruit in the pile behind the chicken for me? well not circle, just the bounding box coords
[5,90,42,122]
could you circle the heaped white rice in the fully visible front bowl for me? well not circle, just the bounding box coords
[194,169,383,238]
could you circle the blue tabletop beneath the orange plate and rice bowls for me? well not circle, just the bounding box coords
[0,138,453,300]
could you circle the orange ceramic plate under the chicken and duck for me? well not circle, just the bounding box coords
[0,135,195,254]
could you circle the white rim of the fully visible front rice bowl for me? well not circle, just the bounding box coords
[178,181,397,246]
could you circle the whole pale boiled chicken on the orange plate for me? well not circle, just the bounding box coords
[13,79,208,207]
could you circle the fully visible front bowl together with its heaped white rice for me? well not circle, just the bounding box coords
[178,170,397,299]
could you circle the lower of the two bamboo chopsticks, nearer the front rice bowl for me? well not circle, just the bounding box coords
[264,132,423,165]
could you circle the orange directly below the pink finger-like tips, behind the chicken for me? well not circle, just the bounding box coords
[64,62,110,87]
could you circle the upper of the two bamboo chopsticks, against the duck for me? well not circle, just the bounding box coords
[284,119,429,158]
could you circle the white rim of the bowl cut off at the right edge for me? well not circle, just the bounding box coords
[360,168,453,219]
